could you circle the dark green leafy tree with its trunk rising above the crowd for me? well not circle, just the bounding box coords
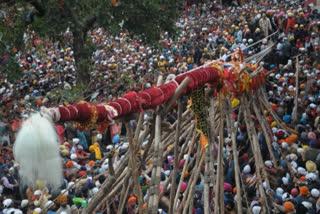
[0,0,183,84]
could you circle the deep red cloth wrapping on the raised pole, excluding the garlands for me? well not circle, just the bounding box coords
[59,67,225,122]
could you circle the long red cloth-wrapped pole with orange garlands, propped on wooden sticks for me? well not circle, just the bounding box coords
[49,64,264,129]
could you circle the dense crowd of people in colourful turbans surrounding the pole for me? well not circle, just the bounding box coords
[0,1,320,214]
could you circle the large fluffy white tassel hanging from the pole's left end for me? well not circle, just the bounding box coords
[13,113,62,189]
